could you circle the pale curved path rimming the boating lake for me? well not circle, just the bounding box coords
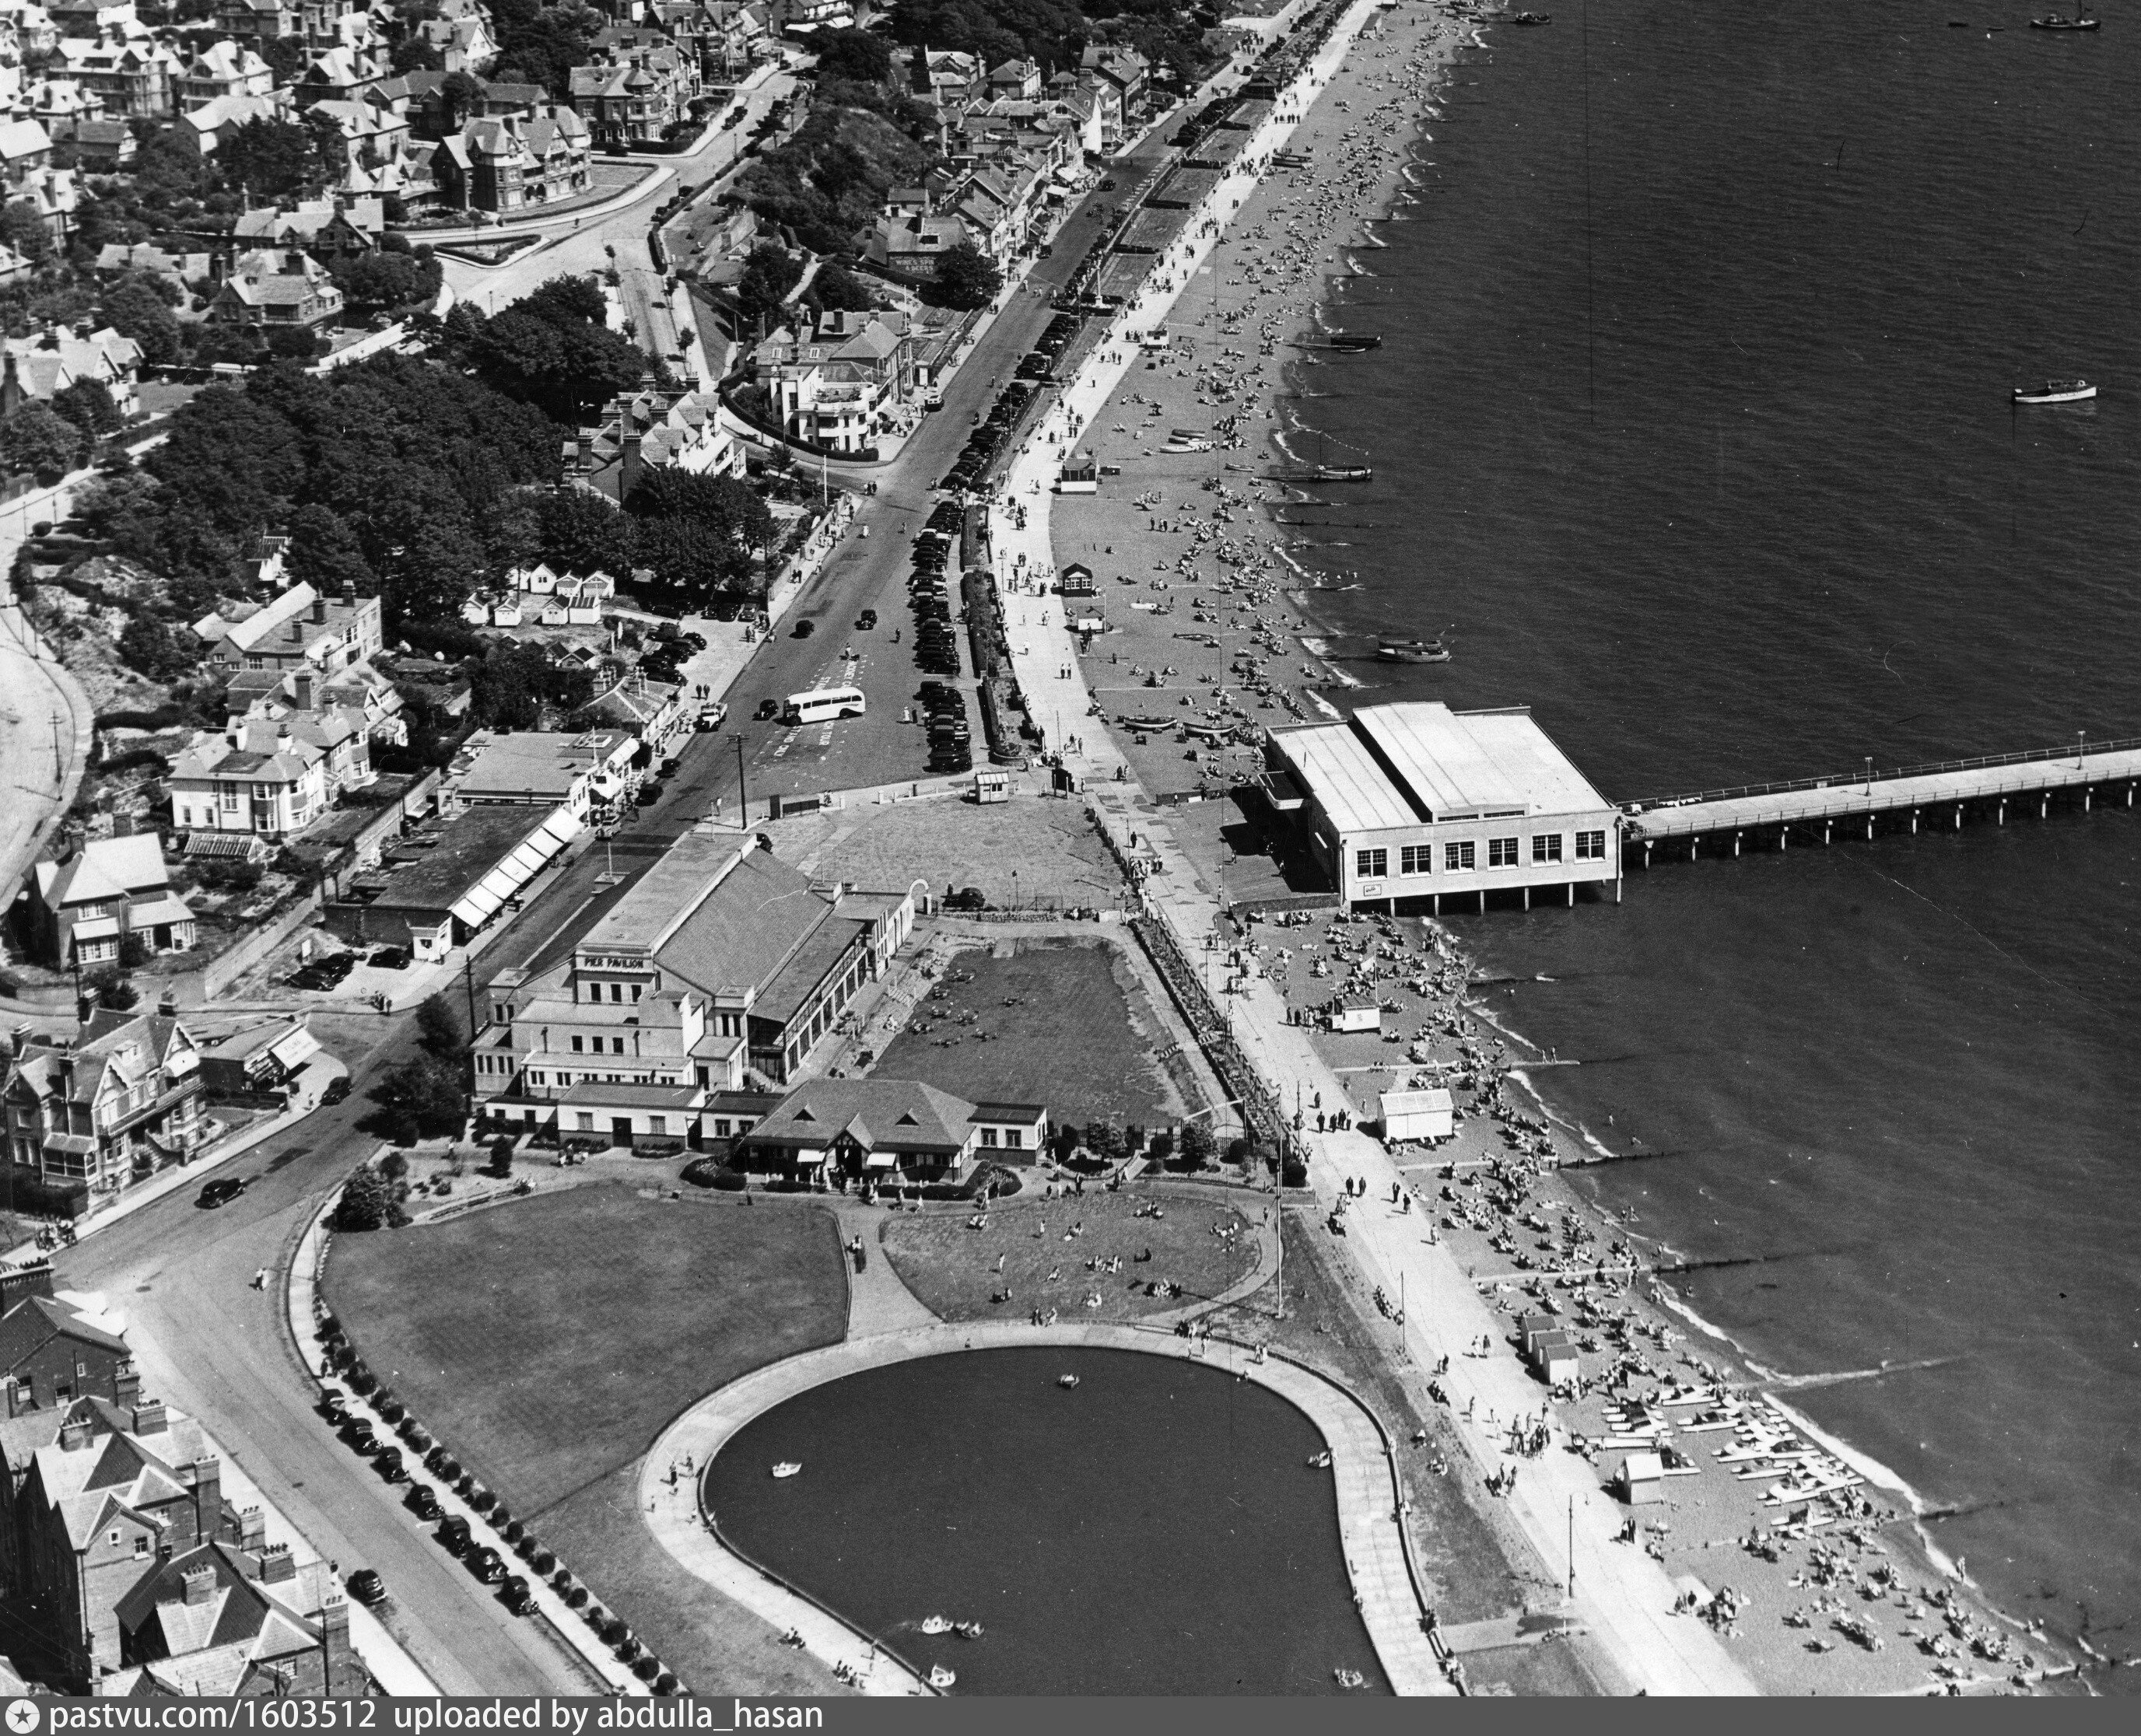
[640,1321,1456,1696]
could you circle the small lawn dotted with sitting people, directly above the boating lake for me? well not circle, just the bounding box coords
[882,1186,1259,1321]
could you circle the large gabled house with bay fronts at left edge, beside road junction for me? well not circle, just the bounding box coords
[0,1006,210,1199]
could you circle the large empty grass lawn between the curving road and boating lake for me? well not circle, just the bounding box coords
[325,1184,848,1528]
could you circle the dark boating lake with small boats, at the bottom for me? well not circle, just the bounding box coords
[703,1349,1389,1696]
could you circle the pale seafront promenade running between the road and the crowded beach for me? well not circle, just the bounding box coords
[991,5,1756,1696]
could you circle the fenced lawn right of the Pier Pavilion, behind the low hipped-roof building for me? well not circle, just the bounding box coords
[869,942,1182,1128]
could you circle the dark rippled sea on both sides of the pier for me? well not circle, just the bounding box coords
[1287,0,2141,1691]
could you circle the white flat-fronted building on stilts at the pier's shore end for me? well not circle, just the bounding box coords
[1263,700,1621,912]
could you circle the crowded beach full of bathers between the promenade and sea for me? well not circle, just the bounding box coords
[1002,6,2070,1693]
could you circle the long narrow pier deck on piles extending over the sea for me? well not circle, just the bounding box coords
[1621,737,2141,867]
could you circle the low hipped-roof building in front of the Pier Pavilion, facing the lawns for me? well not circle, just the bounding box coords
[734,1079,1049,1184]
